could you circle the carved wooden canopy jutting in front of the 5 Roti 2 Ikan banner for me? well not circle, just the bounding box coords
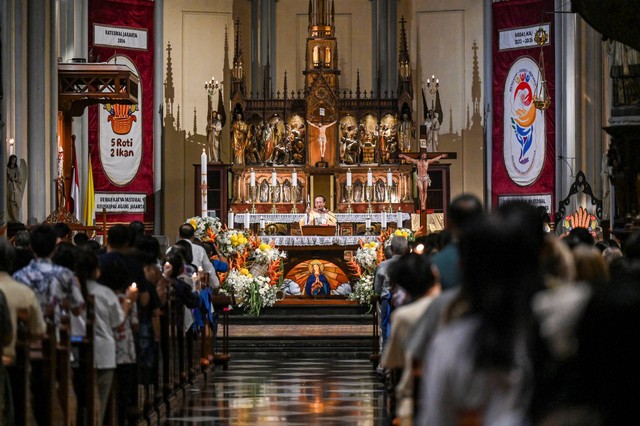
[58,63,139,117]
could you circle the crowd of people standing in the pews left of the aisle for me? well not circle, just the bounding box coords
[0,222,228,426]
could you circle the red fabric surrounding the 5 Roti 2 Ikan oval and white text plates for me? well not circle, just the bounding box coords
[89,0,155,223]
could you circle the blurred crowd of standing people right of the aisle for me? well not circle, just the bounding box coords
[374,194,640,426]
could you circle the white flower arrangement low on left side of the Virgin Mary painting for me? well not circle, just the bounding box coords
[223,268,278,316]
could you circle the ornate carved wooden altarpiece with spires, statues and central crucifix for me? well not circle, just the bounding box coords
[222,6,449,226]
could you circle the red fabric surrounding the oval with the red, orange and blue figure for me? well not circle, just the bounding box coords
[491,0,556,213]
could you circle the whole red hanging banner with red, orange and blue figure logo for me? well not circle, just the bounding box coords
[491,0,556,214]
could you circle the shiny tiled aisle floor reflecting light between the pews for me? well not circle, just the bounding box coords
[166,358,387,426]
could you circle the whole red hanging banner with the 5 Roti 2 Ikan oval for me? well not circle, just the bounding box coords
[89,0,155,228]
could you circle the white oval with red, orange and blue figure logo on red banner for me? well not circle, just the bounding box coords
[503,56,546,186]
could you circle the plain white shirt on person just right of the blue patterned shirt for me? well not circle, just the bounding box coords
[87,281,126,369]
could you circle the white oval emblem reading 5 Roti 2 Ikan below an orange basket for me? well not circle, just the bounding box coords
[99,56,142,186]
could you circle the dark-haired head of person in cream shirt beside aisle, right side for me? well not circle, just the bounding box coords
[389,253,436,299]
